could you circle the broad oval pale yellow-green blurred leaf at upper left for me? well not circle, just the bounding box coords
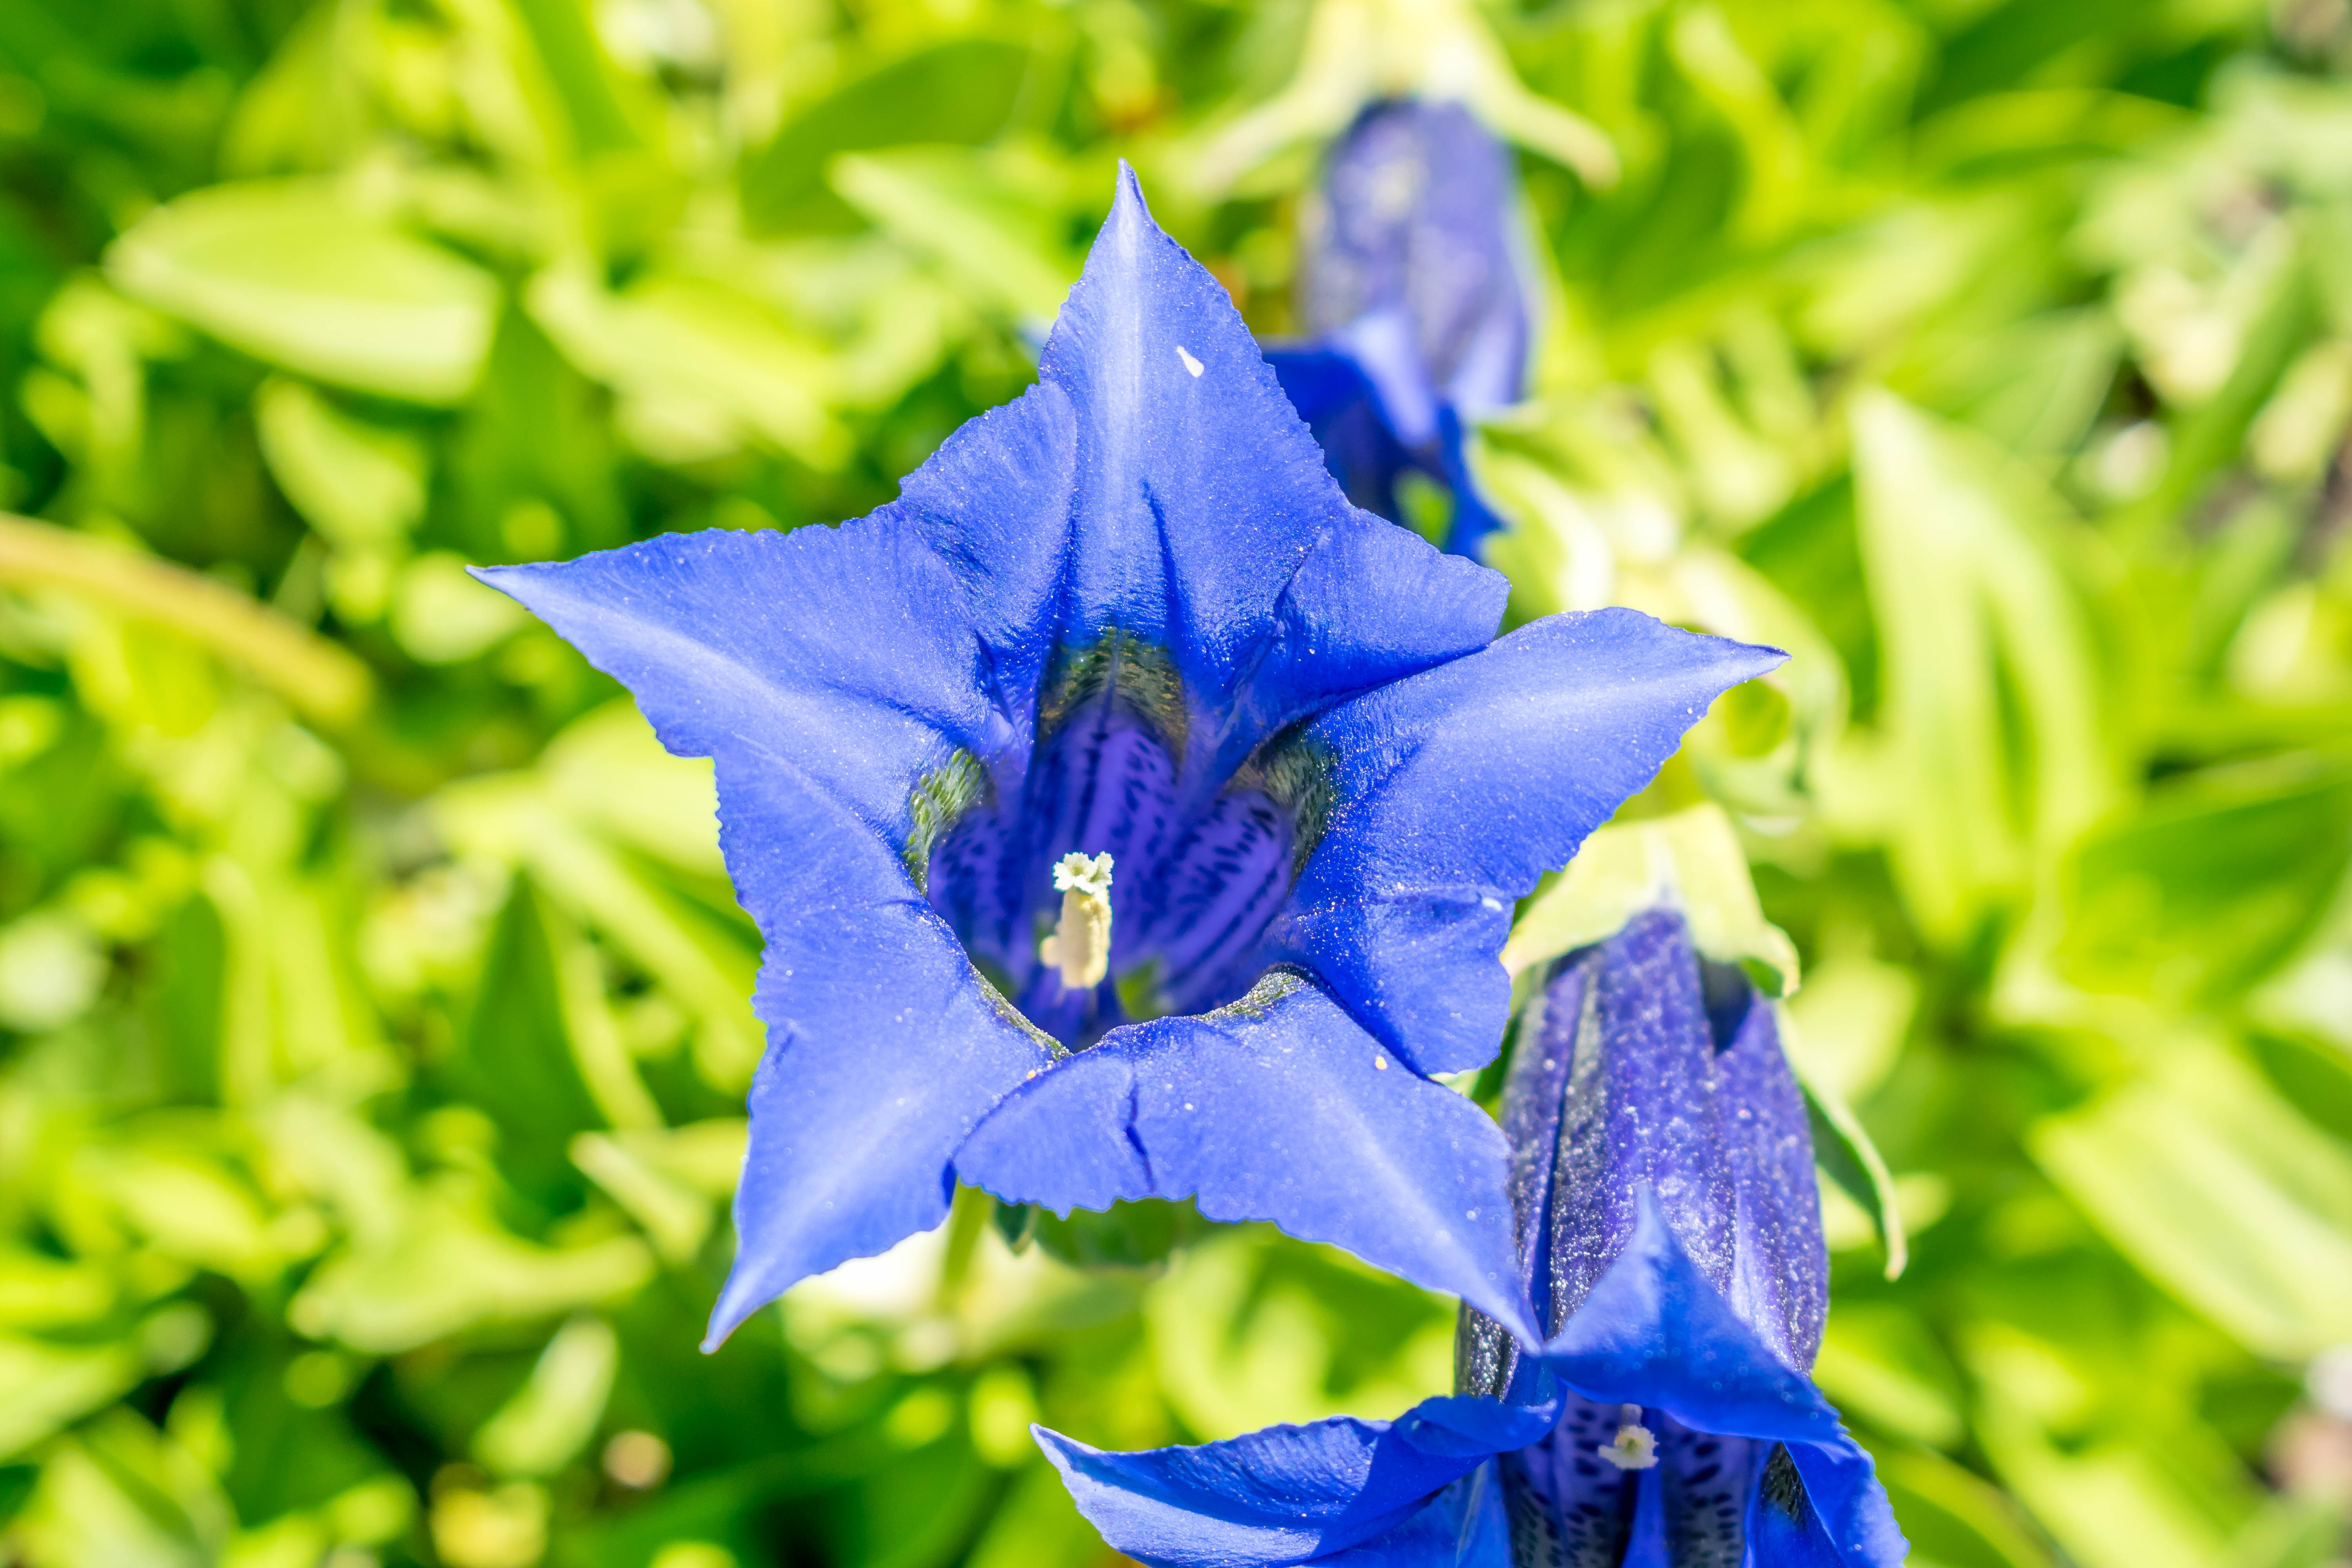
[106,181,499,402]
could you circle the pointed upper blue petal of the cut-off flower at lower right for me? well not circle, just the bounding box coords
[1541,1189,1844,1446]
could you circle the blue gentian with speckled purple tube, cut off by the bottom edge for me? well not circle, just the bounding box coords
[1037,910,1905,1568]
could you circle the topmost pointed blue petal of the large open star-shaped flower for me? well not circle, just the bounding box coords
[882,165,1503,762]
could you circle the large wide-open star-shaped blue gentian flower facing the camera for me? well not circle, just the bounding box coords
[482,174,1780,1340]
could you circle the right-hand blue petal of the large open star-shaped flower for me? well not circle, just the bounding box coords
[1268,609,1785,1072]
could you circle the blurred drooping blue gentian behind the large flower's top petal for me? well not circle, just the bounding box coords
[1268,99,1529,555]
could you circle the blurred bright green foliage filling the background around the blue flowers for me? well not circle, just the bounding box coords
[0,0,2352,1568]
